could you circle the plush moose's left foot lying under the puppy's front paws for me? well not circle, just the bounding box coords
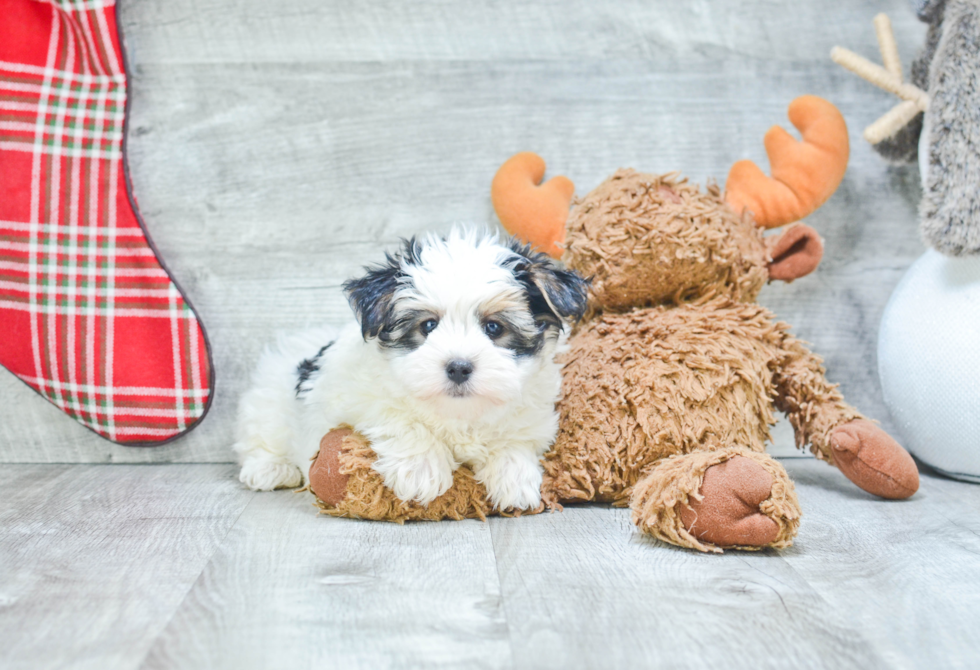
[309,426,490,523]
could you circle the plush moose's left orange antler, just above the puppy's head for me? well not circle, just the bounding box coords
[490,152,575,258]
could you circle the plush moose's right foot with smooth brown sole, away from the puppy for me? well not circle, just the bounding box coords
[630,447,800,552]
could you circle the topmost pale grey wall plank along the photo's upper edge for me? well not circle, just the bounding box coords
[115,0,924,64]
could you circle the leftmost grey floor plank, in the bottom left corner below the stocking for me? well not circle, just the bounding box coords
[0,465,254,670]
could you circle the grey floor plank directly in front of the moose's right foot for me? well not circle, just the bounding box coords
[491,506,888,668]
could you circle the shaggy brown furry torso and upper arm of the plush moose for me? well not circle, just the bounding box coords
[542,295,860,505]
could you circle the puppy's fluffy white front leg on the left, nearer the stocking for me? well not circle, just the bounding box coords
[364,427,459,505]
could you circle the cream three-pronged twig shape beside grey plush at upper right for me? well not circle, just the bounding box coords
[830,14,929,144]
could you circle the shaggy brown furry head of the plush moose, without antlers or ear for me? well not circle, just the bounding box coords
[562,169,769,311]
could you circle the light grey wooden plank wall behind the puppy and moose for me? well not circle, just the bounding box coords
[0,0,925,463]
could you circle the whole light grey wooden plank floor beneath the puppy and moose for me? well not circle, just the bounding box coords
[0,459,980,670]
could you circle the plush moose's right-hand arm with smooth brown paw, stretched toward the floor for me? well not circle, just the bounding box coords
[773,334,919,499]
